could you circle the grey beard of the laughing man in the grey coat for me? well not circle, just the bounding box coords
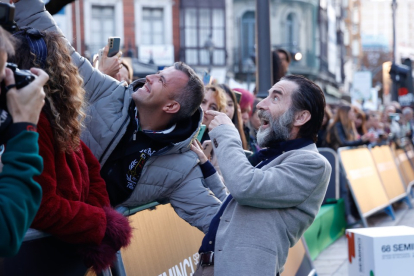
[257,108,295,148]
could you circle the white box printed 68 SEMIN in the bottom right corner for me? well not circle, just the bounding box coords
[346,226,414,276]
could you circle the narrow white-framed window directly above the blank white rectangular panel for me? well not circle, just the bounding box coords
[141,8,164,45]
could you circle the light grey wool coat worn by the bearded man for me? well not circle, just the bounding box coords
[209,125,331,276]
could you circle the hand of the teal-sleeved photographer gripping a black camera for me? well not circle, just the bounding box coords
[5,68,49,125]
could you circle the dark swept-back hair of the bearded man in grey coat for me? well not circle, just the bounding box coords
[281,75,326,142]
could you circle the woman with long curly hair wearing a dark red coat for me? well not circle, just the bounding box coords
[10,28,131,273]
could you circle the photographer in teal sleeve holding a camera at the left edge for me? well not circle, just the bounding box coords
[0,27,49,257]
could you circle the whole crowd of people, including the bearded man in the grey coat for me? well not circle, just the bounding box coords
[0,0,413,275]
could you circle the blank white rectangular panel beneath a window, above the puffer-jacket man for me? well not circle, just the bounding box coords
[139,44,174,66]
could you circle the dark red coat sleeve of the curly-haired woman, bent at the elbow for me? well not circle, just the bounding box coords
[32,113,106,244]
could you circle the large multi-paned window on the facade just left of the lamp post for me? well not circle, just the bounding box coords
[180,0,226,65]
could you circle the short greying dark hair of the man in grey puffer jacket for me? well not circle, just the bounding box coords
[172,61,204,122]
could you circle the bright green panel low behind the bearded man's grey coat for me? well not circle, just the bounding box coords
[304,199,346,260]
